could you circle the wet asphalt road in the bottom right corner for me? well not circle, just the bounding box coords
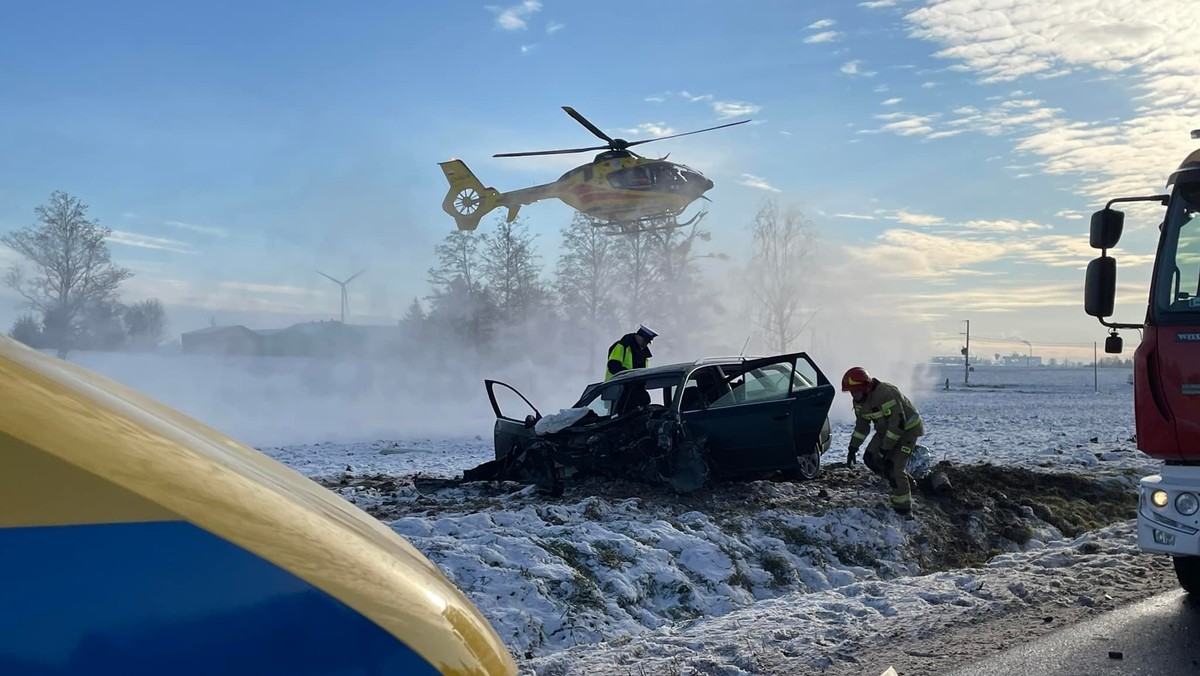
[943,591,1200,676]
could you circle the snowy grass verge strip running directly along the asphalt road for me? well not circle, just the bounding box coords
[528,524,1163,676]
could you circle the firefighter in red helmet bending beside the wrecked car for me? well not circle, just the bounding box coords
[841,366,925,514]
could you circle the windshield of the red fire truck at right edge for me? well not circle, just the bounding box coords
[1153,183,1200,318]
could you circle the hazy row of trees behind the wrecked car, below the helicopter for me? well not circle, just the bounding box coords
[402,199,816,371]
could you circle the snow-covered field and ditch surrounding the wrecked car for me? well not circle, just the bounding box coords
[73,354,1172,674]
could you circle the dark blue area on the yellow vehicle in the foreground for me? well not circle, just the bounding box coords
[0,521,438,676]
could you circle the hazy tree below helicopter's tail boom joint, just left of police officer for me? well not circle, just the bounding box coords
[554,214,624,372]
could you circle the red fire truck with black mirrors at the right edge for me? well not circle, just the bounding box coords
[1084,130,1200,597]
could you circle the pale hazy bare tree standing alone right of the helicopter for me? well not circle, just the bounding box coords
[746,199,816,352]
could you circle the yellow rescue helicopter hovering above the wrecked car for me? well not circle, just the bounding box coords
[438,106,750,233]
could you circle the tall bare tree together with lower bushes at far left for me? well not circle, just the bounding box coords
[0,191,167,358]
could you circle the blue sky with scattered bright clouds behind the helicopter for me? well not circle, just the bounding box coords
[0,0,1200,360]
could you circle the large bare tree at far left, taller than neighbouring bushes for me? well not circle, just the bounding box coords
[0,191,133,358]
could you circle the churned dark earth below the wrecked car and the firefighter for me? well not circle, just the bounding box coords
[318,462,1136,573]
